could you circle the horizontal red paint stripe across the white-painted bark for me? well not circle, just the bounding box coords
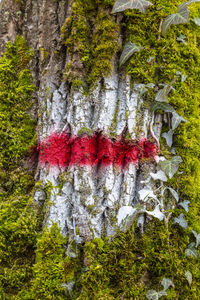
[38,133,157,168]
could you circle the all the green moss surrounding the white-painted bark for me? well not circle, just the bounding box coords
[0,0,200,300]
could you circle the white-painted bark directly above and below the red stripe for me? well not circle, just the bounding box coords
[35,67,161,240]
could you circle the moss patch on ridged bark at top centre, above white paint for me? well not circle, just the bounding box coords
[61,0,119,88]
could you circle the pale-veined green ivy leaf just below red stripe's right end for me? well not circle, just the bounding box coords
[159,156,182,179]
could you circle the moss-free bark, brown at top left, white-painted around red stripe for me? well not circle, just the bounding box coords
[1,0,161,240]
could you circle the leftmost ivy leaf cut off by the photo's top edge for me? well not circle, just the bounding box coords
[112,0,153,13]
